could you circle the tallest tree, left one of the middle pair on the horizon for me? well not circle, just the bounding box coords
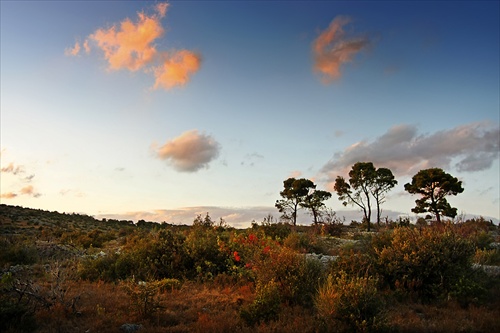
[334,162,376,231]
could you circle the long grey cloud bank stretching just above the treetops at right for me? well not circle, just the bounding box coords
[322,122,500,181]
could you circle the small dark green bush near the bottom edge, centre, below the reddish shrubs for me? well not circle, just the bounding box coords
[240,280,281,326]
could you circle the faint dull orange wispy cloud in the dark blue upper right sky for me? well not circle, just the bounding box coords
[312,16,369,84]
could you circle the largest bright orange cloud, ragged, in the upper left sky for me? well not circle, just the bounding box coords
[65,3,201,89]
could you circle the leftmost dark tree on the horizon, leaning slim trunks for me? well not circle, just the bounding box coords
[275,178,316,225]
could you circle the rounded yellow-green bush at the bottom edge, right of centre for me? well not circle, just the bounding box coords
[315,272,385,332]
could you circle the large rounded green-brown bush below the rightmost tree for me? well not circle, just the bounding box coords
[373,227,474,300]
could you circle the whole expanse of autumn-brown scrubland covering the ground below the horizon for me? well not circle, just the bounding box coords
[0,205,500,333]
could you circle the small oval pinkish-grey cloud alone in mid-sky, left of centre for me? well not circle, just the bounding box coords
[153,130,220,172]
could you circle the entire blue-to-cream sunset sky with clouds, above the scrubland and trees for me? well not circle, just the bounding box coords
[0,0,500,227]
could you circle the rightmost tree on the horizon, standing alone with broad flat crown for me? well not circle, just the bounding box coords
[405,168,464,223]
